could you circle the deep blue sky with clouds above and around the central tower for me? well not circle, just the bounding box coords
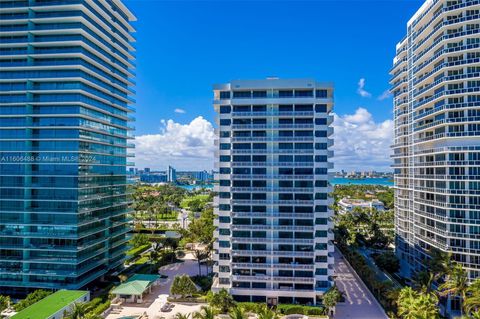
[124,0,422,169]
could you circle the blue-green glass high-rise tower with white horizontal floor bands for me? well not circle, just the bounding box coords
[0,0,134,292]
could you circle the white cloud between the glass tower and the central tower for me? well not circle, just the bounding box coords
[135,116,215,170]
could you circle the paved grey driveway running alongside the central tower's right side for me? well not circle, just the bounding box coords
[334,248,388,319]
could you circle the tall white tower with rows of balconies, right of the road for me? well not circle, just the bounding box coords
[391,0,480,278]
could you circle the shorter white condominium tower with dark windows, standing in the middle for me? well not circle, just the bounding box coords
[213,78,333,304]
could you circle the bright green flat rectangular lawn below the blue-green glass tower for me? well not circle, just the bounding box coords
[12,290,87,319]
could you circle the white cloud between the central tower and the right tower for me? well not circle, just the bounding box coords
[333,107,393,171]
